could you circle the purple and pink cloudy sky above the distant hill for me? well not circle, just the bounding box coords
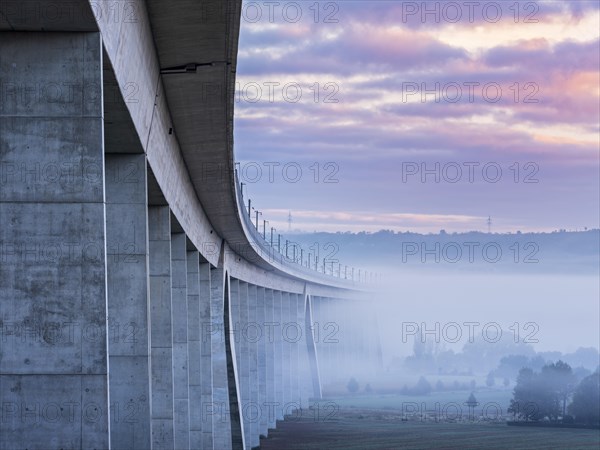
[234,1,600,233]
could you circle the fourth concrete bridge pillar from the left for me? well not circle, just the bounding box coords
[171,233,190,449]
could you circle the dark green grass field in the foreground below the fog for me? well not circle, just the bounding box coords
[260,410,600,450]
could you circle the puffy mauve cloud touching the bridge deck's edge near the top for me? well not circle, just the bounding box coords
[238,20,467,77]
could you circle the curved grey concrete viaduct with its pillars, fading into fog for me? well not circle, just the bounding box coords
[0,0,380,449]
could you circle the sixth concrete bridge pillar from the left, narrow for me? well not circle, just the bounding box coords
[197,263,216,450]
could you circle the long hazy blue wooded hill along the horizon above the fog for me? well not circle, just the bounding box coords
[282,229,600,274]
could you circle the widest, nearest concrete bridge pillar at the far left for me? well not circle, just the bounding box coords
[0,32,110,448]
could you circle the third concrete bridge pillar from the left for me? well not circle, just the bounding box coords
[148,206,175,449]
